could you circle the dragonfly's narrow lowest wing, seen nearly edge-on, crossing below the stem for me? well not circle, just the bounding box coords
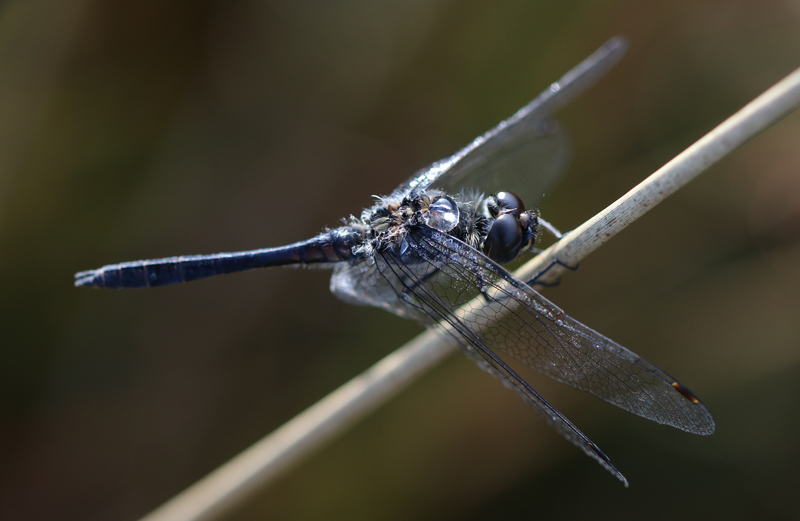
[331,248,628,487]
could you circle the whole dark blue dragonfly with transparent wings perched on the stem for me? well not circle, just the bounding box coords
[75,37,714,487]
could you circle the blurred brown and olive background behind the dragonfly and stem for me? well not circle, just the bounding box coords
[0,0,800,520]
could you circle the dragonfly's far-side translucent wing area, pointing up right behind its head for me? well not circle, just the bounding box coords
[395,37,627,207]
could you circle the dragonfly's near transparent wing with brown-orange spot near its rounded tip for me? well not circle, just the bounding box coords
[408,228,714,435]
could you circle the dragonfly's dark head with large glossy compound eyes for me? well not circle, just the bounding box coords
[483,191,539,264]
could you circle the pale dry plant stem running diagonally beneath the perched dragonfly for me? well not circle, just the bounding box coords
[144,65,800,521]
